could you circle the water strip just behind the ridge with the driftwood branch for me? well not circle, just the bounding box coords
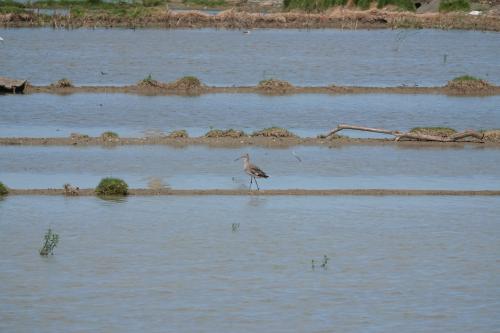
[0,94,500,137]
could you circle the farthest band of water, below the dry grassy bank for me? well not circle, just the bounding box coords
[0,29,500,86]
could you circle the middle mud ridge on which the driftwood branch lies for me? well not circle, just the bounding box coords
[0,136,500,148]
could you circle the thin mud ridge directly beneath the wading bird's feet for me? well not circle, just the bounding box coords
[8,188,500,197]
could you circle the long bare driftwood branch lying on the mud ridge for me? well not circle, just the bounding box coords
[326,124,484,142]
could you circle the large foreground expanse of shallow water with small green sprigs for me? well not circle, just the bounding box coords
[0,196,500,333]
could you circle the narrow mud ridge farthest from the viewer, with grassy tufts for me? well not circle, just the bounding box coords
[21,85,500,96]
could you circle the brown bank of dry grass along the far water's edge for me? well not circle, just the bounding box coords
[0,9,500,31]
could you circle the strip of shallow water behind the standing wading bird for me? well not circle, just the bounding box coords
[0,146,500,190]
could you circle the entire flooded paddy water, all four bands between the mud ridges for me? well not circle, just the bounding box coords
[0,25,500,333]
